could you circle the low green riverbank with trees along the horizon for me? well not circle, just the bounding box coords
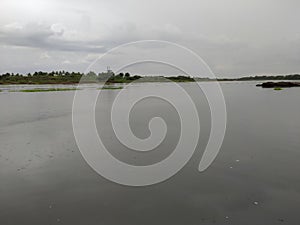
[0,71,300,85]
